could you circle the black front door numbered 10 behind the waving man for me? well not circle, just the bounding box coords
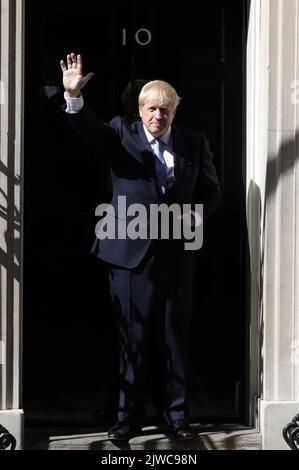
[24,0,246,421]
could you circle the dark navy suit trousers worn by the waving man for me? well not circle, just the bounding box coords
[108,240,194,424]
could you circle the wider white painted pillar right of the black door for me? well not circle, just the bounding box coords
[247,0,299,449]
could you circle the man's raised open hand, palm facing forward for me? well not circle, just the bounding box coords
[60,53,93,96]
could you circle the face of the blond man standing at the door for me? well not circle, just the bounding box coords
[139,97,176,137]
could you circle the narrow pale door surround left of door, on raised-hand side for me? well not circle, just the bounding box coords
[0,0,24,448]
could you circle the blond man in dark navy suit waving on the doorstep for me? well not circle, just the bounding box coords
[60,53,220,441]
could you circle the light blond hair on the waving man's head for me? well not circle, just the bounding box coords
[138,80,181,109]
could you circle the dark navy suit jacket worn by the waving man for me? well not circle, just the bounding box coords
[68,105,220,269]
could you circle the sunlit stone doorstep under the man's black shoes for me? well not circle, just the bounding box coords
[25,424,262,451]
